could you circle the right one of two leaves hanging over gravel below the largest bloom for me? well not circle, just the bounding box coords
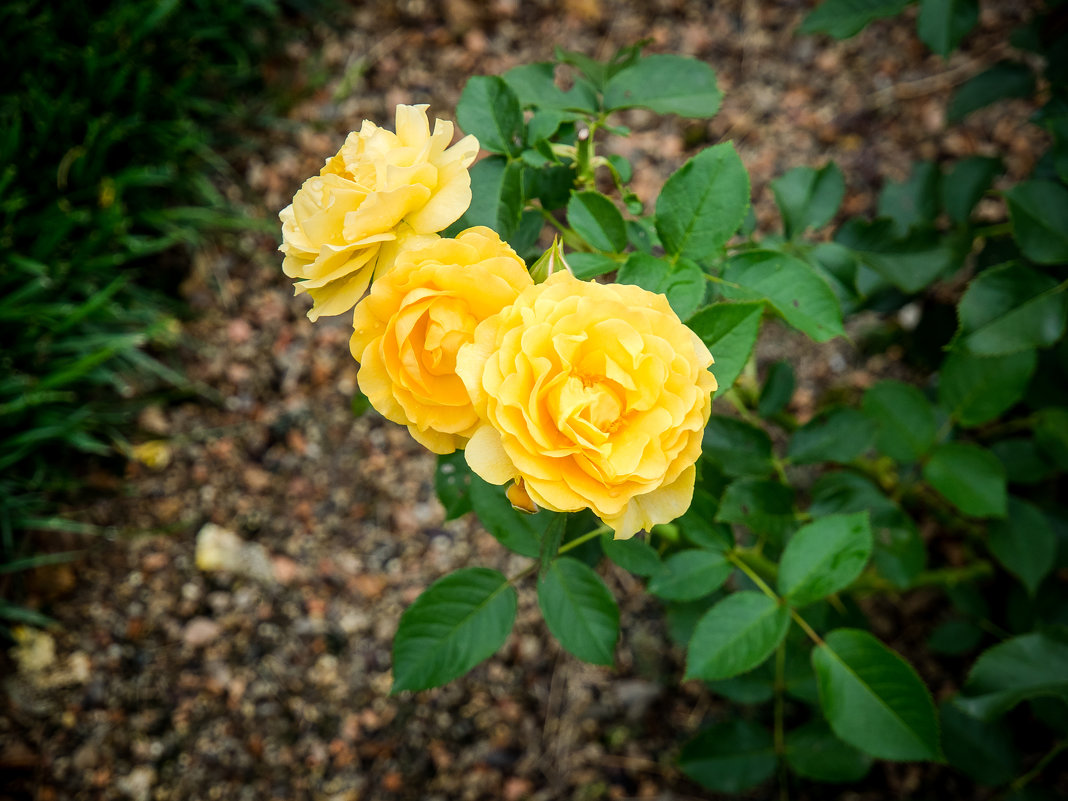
[537,556,619,664]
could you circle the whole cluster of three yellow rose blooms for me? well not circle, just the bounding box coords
[280,106,716,537]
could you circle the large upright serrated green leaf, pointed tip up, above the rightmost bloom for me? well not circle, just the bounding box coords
[656,142,749,262]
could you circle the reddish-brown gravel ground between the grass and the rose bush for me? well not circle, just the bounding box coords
[0,0,1041,801]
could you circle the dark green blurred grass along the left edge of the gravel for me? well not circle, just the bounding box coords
[0,0,321,589]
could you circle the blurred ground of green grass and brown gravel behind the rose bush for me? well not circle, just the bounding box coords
[0,0,1045,801]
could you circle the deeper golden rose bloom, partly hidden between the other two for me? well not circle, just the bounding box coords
[349,226,533,453]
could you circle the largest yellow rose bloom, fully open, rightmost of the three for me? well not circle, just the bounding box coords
[456,272,716,538]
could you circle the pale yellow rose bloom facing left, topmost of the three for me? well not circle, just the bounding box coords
[279,106,478,320]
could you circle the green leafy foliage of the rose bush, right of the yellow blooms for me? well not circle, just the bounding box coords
[405,28,1068,798]
